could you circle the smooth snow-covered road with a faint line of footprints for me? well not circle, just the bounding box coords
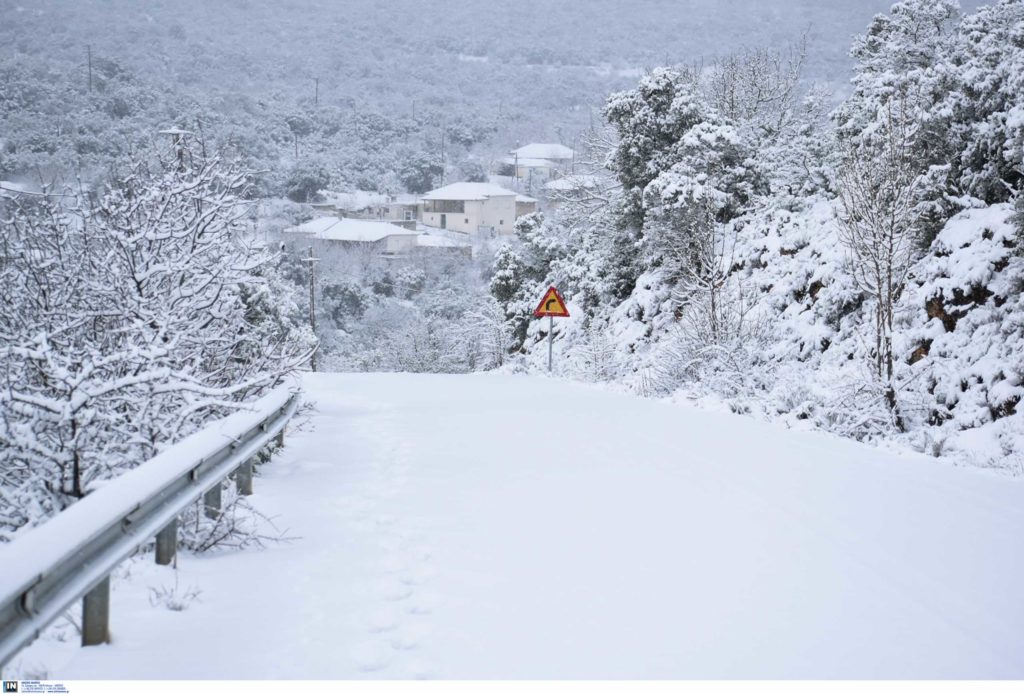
[18,375,1024,679]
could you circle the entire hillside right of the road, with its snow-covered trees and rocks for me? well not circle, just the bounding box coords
[490,0,1024,475]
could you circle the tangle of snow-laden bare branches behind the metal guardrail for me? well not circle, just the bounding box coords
[0,145,312,534]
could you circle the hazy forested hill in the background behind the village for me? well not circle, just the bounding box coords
[0,0,966,194]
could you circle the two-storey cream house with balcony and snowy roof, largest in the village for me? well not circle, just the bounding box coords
[420,182,518,235]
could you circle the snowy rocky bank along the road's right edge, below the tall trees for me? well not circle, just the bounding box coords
[532,199,1024,476]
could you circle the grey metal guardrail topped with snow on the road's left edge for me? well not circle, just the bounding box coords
[0,386,299,664]
